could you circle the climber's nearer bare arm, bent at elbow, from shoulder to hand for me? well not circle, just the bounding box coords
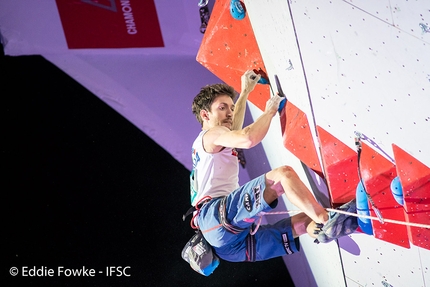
[203,96,282,153]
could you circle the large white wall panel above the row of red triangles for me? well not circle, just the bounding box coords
[292,1,430,165]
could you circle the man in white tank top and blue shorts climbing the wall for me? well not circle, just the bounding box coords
[191,70,358,262]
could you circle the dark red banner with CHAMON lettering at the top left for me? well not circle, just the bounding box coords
[56,0,164,49]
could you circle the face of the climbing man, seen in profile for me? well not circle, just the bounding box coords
[207,95,234,129]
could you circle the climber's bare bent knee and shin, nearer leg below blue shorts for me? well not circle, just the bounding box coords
[264,166,328,224]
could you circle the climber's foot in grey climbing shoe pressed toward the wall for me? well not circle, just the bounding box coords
[314,199,358,243]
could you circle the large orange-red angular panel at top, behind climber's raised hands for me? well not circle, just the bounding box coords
[197,0,270,110]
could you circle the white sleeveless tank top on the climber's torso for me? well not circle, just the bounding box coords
[190,131,239,206]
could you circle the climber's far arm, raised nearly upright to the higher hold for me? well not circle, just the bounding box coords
[232,70,261,130]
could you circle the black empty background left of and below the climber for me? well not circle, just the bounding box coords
[0,46,293,286]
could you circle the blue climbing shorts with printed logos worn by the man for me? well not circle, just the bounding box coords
[198,175,299,262]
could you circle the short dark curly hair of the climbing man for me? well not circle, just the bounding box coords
[192,84,237,126]
